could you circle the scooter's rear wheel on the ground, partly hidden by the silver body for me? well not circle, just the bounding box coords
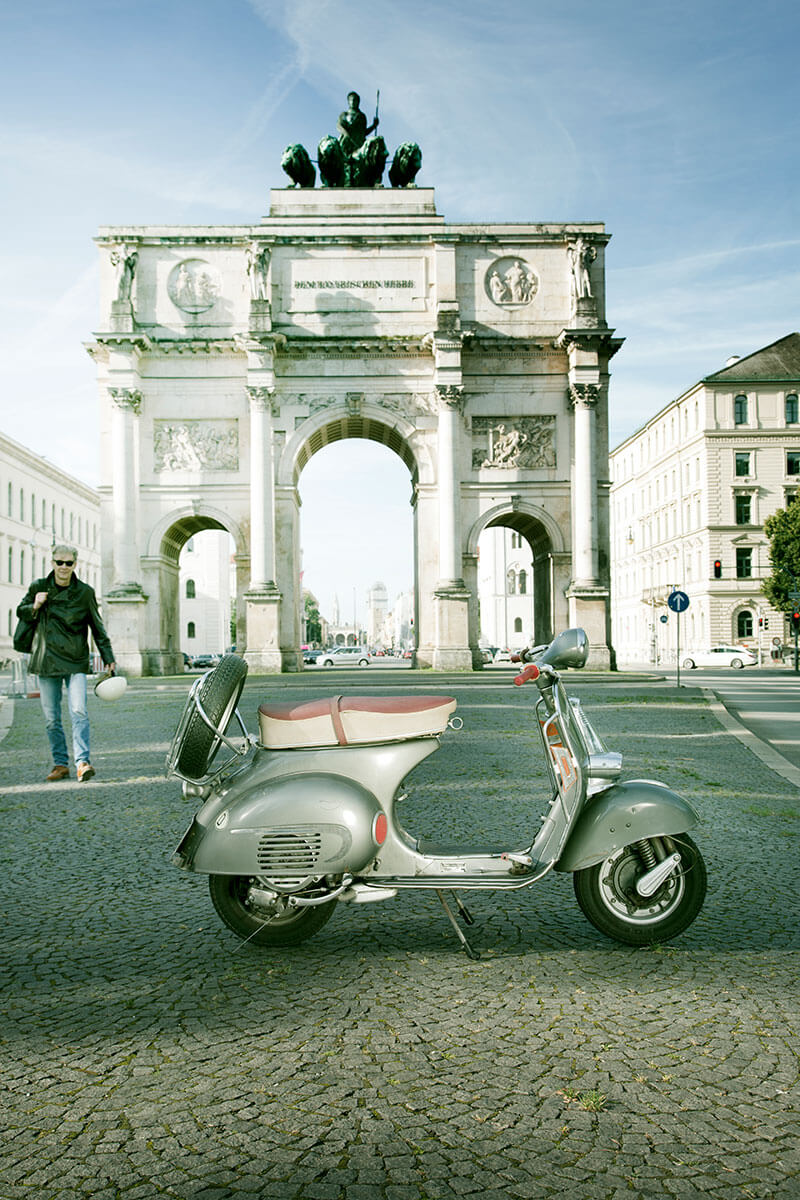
[209,875,336,946]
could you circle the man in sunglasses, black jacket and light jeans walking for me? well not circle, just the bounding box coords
[17,545,116,784]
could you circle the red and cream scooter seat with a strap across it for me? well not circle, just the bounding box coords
[258,696,456,750]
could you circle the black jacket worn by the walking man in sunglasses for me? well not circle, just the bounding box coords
[17,571,114,676]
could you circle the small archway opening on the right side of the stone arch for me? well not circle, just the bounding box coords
[477,512,554,658]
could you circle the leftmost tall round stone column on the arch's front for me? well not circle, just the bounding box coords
[108,388,142,595]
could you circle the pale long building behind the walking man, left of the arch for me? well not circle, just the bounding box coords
[0,433,101,660]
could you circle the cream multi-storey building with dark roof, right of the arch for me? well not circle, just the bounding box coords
[610,334,800,662]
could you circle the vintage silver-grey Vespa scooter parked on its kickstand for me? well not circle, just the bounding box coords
[167,629,706,958]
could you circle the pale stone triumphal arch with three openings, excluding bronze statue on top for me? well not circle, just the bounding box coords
[89,113,620,674]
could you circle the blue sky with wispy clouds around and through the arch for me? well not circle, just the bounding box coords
[0,0,800,607]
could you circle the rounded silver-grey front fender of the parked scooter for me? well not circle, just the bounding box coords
[554,779,699,871]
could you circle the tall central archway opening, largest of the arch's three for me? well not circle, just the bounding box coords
[299,436,415,654]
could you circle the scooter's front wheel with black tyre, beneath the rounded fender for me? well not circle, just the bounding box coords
[573,833,706,946]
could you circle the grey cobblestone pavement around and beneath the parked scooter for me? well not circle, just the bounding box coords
[0,672,800,1200]
